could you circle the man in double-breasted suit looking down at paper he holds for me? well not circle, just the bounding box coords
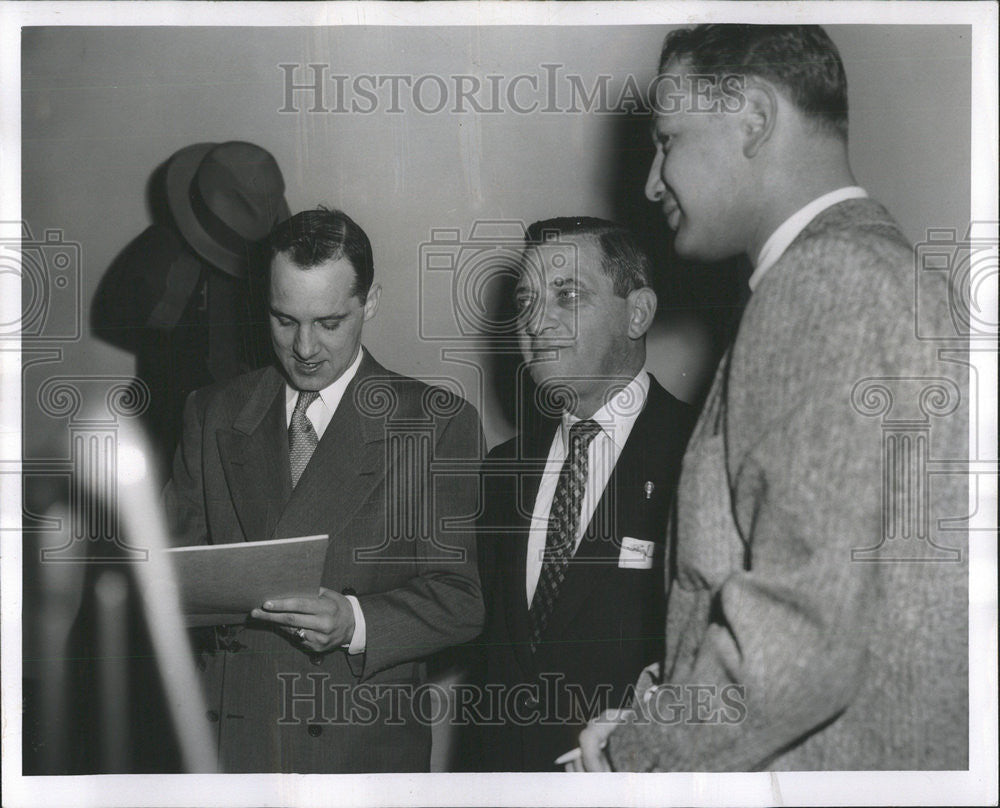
[166,209,483,773]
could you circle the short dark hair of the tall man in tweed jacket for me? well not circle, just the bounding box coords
[660,24,847,140]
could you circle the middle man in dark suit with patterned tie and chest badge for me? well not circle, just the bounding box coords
[479,218,694,771]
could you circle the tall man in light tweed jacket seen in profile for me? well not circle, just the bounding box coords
[580,25,968,771]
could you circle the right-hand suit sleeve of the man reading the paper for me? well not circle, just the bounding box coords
[356,404,483,678]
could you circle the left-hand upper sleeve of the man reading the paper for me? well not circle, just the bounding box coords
[163,391,208,547]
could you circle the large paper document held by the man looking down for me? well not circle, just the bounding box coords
[166,536,330,626]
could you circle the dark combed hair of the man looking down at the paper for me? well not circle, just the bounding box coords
[267,207,375,302]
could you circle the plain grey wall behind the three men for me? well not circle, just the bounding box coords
[22,26,971,457]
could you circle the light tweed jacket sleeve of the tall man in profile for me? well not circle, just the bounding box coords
[609,232,956,771]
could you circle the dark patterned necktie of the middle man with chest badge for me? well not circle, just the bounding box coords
[530,419,601,650]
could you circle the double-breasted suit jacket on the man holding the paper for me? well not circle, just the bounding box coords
[166,352,483,773]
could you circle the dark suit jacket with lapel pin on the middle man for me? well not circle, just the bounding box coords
[479,377,695,771]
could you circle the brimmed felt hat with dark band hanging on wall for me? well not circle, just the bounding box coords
[166,140,290,278]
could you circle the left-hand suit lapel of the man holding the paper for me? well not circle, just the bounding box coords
[216,368,292,541]
